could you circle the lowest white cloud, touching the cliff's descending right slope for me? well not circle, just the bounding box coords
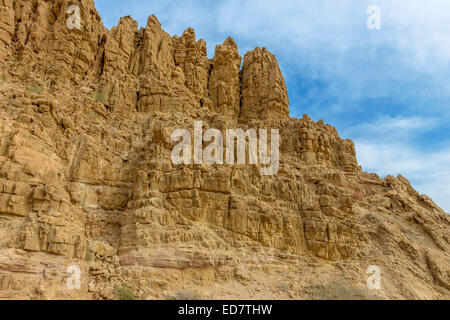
[344,116,450,212]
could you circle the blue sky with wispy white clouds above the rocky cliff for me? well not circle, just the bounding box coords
[94,0,450,212]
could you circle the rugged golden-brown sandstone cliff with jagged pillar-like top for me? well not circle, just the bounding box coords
[0,0,450,299]
